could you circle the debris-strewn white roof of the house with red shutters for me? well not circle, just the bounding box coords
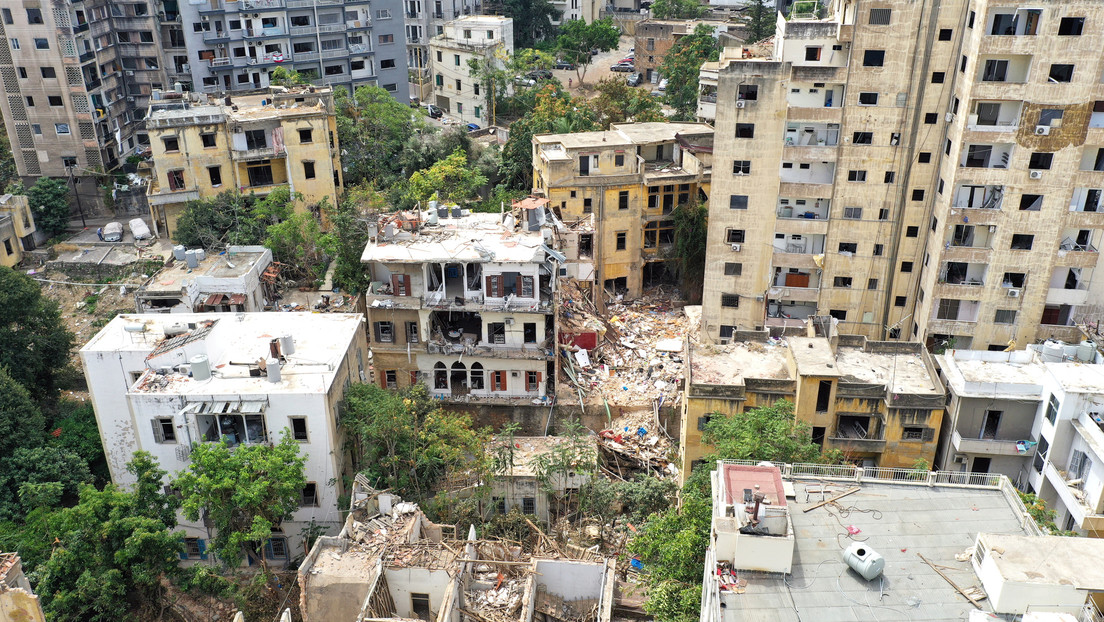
[360,212,545,264]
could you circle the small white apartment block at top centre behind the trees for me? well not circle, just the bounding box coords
[429,15,513,125]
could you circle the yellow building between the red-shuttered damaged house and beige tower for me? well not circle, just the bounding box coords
[533,123,713,298]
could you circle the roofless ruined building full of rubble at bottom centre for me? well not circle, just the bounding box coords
[298,476,616,622]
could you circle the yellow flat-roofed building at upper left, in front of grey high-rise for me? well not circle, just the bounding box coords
[146,86,341,236]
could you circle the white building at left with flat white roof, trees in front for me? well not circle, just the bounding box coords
[81,313,369,563]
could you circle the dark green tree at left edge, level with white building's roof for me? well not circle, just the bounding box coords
[0,266,73,408]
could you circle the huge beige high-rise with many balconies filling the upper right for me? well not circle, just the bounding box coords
[699,0,1104,348]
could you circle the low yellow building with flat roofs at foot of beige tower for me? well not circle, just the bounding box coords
[679,331,945,481]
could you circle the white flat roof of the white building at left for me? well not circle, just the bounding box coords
[81,313,363,396]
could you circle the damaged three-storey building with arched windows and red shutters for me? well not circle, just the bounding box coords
[361,201,565,404]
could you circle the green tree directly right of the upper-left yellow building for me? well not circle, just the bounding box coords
[335,86,426,188]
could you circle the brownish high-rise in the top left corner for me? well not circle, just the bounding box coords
[0,0,166,212]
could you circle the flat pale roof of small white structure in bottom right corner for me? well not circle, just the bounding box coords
[980,533,1104,590]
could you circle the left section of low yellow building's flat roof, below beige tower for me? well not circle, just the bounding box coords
[690,341,794,384]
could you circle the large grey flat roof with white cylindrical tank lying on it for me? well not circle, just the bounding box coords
[721,479,1033,622]
